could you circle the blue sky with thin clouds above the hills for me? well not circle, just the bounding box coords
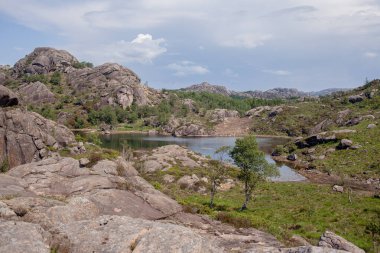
[0,0,380,91]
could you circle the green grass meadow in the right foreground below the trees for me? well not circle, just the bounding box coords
[177,183,380,252]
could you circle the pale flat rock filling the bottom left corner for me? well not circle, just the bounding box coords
[0,221,51,253]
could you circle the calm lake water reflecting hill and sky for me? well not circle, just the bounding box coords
[100,134,305,181]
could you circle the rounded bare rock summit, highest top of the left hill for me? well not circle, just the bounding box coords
[13,47,78,76]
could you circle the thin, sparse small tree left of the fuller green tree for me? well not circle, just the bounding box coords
[209,146,230,208]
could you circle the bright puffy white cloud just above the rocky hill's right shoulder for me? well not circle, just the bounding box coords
[87,34,167,64]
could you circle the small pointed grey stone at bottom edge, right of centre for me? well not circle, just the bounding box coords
[318,231,365,253]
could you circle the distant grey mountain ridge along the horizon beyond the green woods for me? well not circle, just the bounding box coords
[180,82,348,99]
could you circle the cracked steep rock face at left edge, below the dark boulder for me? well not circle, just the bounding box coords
[0,109,75,168]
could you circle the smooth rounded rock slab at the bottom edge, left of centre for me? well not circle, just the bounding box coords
[51,216,223,253]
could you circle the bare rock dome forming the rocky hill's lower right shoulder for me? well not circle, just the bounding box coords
[68,63,158,109]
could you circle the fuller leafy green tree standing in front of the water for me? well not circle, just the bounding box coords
[230,135,278,210]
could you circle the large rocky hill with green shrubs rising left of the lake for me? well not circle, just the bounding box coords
[0,47,163,125]
